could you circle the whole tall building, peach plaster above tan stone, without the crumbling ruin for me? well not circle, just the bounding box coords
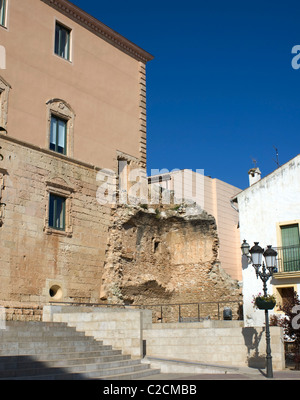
[0,0,153,318]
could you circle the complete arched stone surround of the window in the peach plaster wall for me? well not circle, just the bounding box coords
[46,99,75,157]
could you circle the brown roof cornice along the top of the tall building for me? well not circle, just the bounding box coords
[41,0,154,63]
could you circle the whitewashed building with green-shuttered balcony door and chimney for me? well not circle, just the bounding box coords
[233,155,300,326]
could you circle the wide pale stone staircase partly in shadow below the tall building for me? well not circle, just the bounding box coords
[0,321,160,380]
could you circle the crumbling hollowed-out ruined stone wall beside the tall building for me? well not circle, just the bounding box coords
[100,206,241,320]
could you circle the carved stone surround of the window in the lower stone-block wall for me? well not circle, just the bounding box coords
[44,178,74,237]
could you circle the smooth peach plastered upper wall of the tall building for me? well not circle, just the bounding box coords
[0,0,152,169]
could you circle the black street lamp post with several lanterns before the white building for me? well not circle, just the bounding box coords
[241,240,277,378]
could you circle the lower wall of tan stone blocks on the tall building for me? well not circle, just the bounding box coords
[0,136,110,303]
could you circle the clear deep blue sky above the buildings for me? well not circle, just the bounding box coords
[72,0,300,189]
